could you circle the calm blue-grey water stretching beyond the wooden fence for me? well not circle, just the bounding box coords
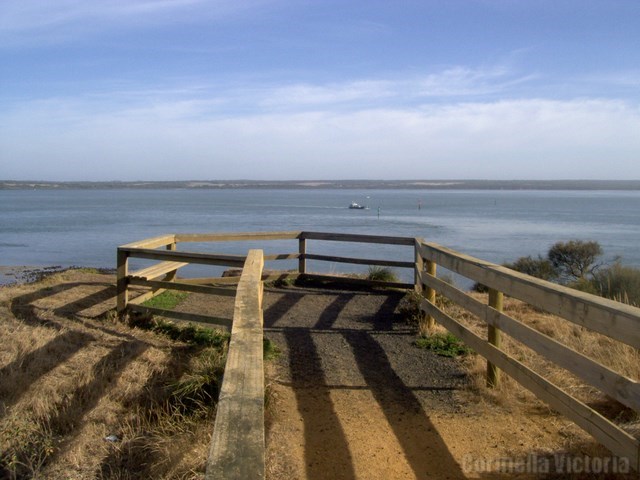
[0,190,640,282]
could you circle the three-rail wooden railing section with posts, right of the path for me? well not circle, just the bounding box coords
[416,239,640,471]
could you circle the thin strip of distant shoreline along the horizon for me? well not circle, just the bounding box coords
[0,180,640,190]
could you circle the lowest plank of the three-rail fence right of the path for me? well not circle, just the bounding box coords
[422,300,640,466]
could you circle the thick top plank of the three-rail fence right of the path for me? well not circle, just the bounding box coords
[419,243,640,348]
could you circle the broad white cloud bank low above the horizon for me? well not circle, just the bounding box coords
[0,91,640,180]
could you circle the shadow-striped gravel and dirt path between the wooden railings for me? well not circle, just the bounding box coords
[264,288,596,480]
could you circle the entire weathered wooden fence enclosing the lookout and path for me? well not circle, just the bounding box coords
[117,232,640,478]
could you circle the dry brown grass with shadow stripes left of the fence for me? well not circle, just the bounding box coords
[0,271,230,479]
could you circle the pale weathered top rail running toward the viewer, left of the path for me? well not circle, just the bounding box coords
[205,250,265,480]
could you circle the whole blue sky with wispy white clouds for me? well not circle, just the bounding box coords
[0,0,640,181]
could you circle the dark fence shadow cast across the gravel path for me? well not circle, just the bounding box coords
[265,291,464,479]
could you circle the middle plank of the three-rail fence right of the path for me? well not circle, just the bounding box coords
[422,275,640,411]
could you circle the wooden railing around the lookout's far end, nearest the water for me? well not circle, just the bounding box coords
[117,232,415,320]
